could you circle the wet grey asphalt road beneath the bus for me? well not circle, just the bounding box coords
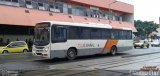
[0,47,160,76]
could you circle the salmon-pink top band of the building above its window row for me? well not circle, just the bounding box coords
[71,0,134,13]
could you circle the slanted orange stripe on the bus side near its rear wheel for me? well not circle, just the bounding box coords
[102,40,118,53]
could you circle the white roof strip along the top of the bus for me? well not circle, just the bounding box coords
[39,21,132,30]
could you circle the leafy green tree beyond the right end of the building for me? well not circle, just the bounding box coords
[134,20,159,38]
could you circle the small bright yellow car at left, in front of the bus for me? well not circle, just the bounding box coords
[0,41,29,54]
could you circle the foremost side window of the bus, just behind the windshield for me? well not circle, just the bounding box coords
[54,27,67,42]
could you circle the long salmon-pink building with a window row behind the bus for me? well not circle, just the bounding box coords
[0,0,136,43]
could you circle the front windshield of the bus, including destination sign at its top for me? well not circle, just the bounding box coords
[34,23,50,46]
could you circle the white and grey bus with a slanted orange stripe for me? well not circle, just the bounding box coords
[32,21,133,60]
